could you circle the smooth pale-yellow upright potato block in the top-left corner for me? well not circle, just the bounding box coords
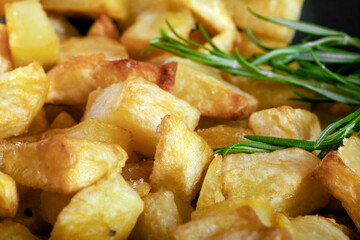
[5,1,59,68]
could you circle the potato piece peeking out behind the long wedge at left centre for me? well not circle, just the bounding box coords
[41,119,132,155]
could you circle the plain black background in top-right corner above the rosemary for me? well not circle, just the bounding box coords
[294,0,360,42]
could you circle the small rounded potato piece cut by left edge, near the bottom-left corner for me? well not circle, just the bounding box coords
[0,172,19,218]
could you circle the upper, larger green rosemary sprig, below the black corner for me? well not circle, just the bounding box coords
[150,15,360,105]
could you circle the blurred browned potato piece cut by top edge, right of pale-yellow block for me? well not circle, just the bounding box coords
[41,0,128,20]
